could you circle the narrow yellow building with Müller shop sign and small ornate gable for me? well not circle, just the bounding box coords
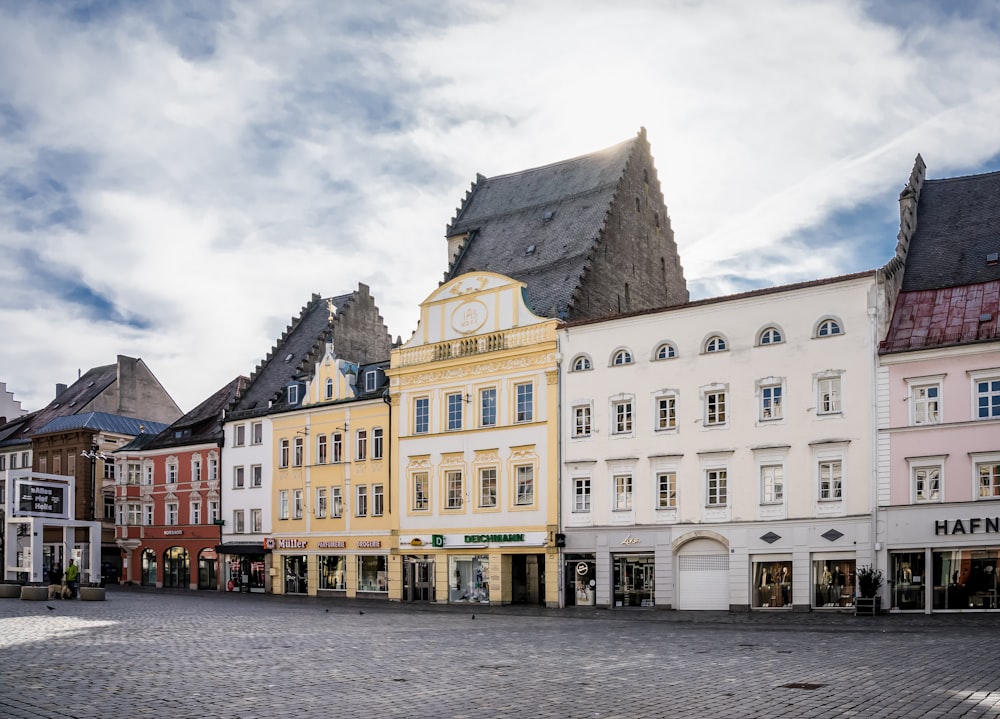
[265,344,399,599]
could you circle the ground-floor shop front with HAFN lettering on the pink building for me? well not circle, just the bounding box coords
[886,502,1000,613]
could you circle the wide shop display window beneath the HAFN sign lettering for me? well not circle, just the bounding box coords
[933,548,1000,609]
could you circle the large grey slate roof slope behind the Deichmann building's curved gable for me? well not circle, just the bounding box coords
[445,138,638,317]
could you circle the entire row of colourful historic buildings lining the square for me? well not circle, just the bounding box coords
[0,131,1000,612]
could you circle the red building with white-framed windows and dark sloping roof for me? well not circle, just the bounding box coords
[114,377,247,589]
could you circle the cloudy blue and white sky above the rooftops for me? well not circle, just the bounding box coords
[0,0,1000,411]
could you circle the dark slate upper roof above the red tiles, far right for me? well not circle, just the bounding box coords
[902,172,1000,292]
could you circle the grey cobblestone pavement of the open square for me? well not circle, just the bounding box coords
[0,588,1000,719]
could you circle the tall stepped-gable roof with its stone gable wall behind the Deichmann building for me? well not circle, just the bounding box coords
[444,129,688,319]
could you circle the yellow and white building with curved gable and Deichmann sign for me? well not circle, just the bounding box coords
[388,272,559,607]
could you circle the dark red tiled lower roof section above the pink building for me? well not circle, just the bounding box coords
[879,280,1000,354]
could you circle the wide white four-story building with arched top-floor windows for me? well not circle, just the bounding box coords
[559,270,891,610]
